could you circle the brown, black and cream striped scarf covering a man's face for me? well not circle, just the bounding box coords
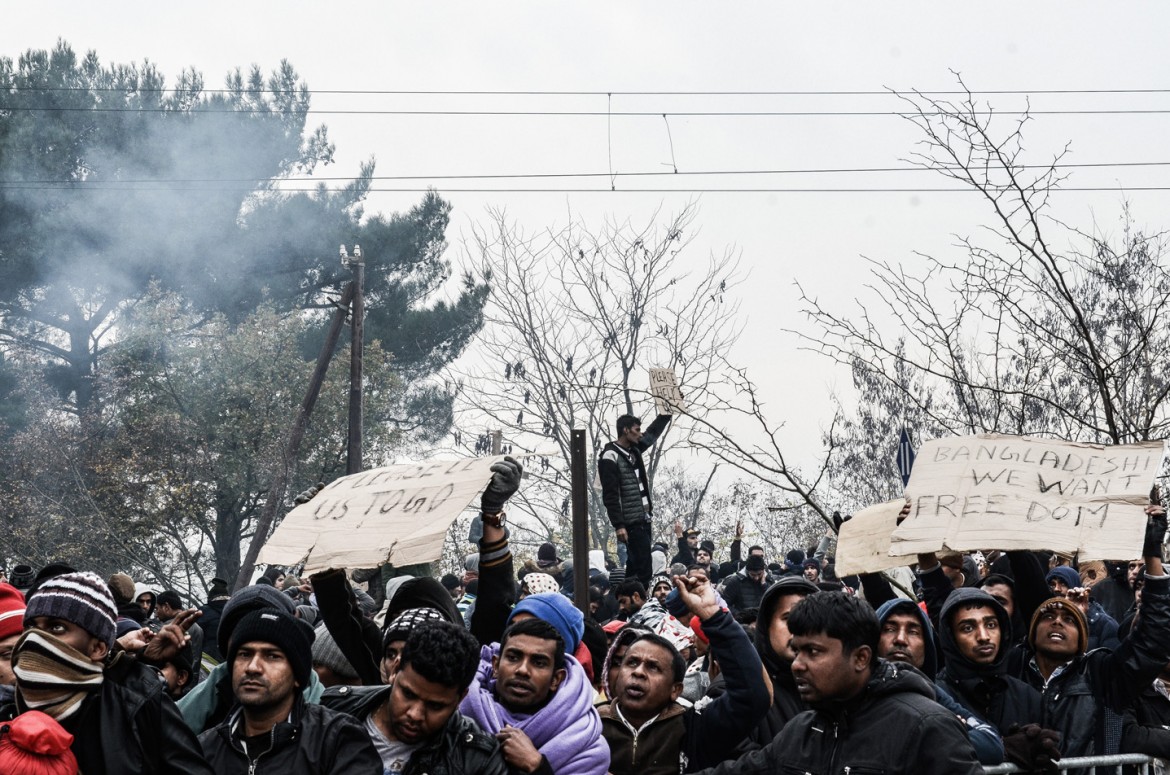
[12,630,103,721]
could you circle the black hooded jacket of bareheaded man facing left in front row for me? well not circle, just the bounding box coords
[703,659,983,775]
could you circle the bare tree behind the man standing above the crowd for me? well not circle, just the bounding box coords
[455,206,739,559]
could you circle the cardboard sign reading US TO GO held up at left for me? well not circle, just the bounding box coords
[259,457,503,574]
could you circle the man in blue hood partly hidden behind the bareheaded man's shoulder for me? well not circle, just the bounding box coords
[878,598,1004,764]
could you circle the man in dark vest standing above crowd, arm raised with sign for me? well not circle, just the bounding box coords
[597,414,670,589]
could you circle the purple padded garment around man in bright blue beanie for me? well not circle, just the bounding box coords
[459,643,610,775]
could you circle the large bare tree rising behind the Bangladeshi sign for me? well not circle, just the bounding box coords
[797,81,1170,502]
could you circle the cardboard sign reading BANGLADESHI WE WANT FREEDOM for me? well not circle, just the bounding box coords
[889,434,1163,560]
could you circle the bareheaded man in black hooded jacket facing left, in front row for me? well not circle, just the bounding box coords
[687,592,983,775]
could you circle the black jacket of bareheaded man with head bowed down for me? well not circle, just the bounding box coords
[321,686,508,775]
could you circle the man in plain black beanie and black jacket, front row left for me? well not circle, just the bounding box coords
[199,610,381,775]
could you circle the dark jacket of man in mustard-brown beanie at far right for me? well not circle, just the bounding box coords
[1025,577,1170,756]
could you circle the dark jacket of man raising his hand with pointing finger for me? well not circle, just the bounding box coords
[598,608,768,775]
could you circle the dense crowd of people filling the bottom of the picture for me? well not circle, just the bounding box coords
[0,451,1170,775]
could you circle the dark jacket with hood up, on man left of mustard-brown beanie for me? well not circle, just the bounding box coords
[936,587,1041,735]
